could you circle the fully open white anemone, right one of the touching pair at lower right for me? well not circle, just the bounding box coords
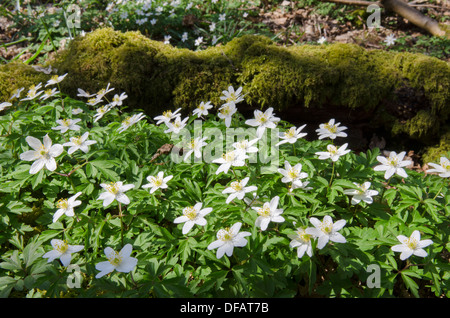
[305,215,347,249]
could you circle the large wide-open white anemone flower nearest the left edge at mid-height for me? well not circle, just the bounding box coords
[20,135,64,174]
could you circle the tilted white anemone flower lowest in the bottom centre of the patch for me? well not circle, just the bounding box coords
[208,222,252,258]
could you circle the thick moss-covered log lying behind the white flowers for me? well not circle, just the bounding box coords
[0,29,450,159]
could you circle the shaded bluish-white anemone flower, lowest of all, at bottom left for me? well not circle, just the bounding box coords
[95,244,138,278]
